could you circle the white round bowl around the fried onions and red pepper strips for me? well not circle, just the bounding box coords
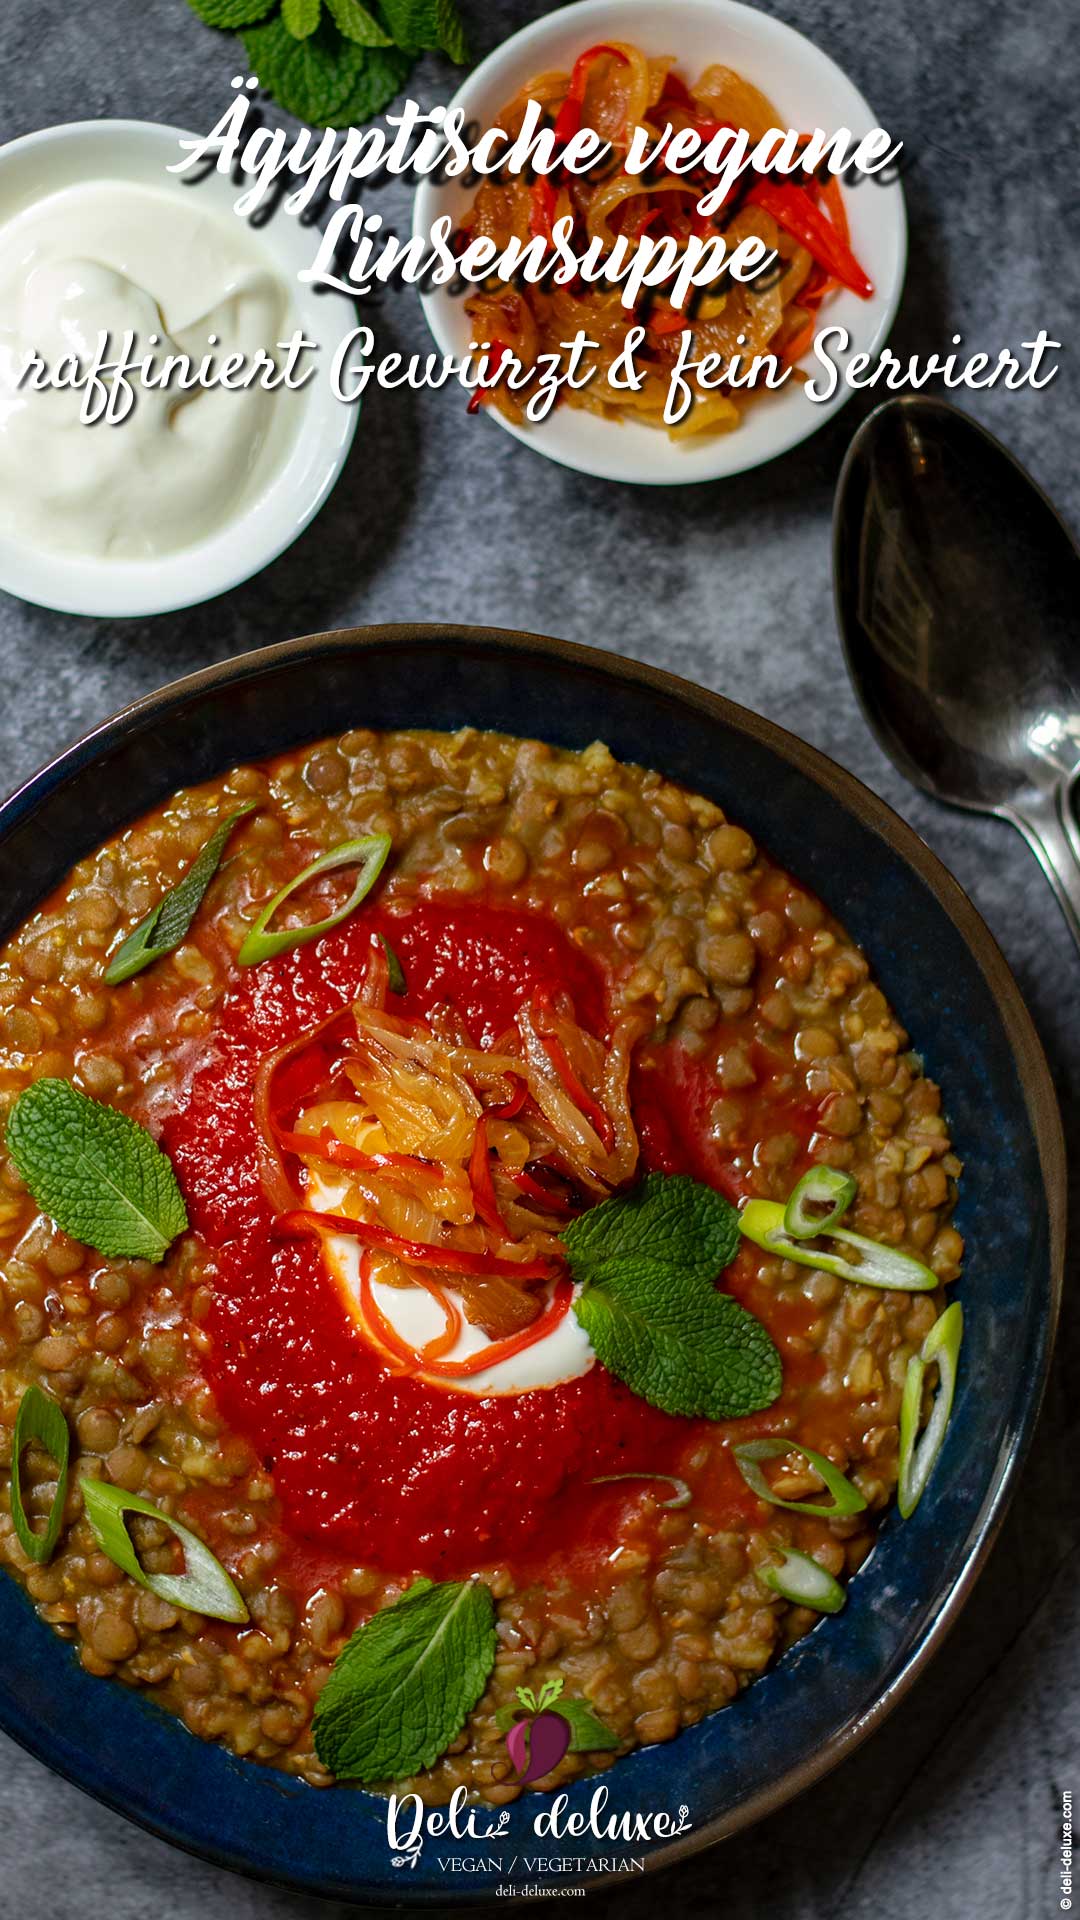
[413,0,907,486]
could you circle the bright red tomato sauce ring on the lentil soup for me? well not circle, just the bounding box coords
[163,902,813,1578]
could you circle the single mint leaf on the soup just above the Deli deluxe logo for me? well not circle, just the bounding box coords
[313,1580,496,1782]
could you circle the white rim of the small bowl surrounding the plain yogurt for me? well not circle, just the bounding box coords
[0,119,359,616]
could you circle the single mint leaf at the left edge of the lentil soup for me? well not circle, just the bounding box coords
[8,1079,188,1263]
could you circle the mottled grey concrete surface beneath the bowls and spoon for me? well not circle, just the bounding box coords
[0,0,1080,1920]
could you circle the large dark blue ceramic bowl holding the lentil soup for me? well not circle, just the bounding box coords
[0,626,1065,1905]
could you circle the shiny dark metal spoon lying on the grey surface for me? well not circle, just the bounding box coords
[832,396,1080,947]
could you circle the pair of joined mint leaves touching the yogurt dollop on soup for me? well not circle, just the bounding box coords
[563,1173,782,1421]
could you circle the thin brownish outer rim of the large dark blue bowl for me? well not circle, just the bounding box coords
[0,622,1067,1905]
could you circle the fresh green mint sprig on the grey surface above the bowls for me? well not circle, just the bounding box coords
[188,0,469,127]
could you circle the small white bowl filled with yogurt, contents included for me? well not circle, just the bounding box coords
[0,121,357,614]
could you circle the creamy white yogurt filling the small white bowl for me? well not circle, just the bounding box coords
[0,180,298,559]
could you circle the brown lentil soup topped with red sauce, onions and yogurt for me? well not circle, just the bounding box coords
[0,730,963,1805]
